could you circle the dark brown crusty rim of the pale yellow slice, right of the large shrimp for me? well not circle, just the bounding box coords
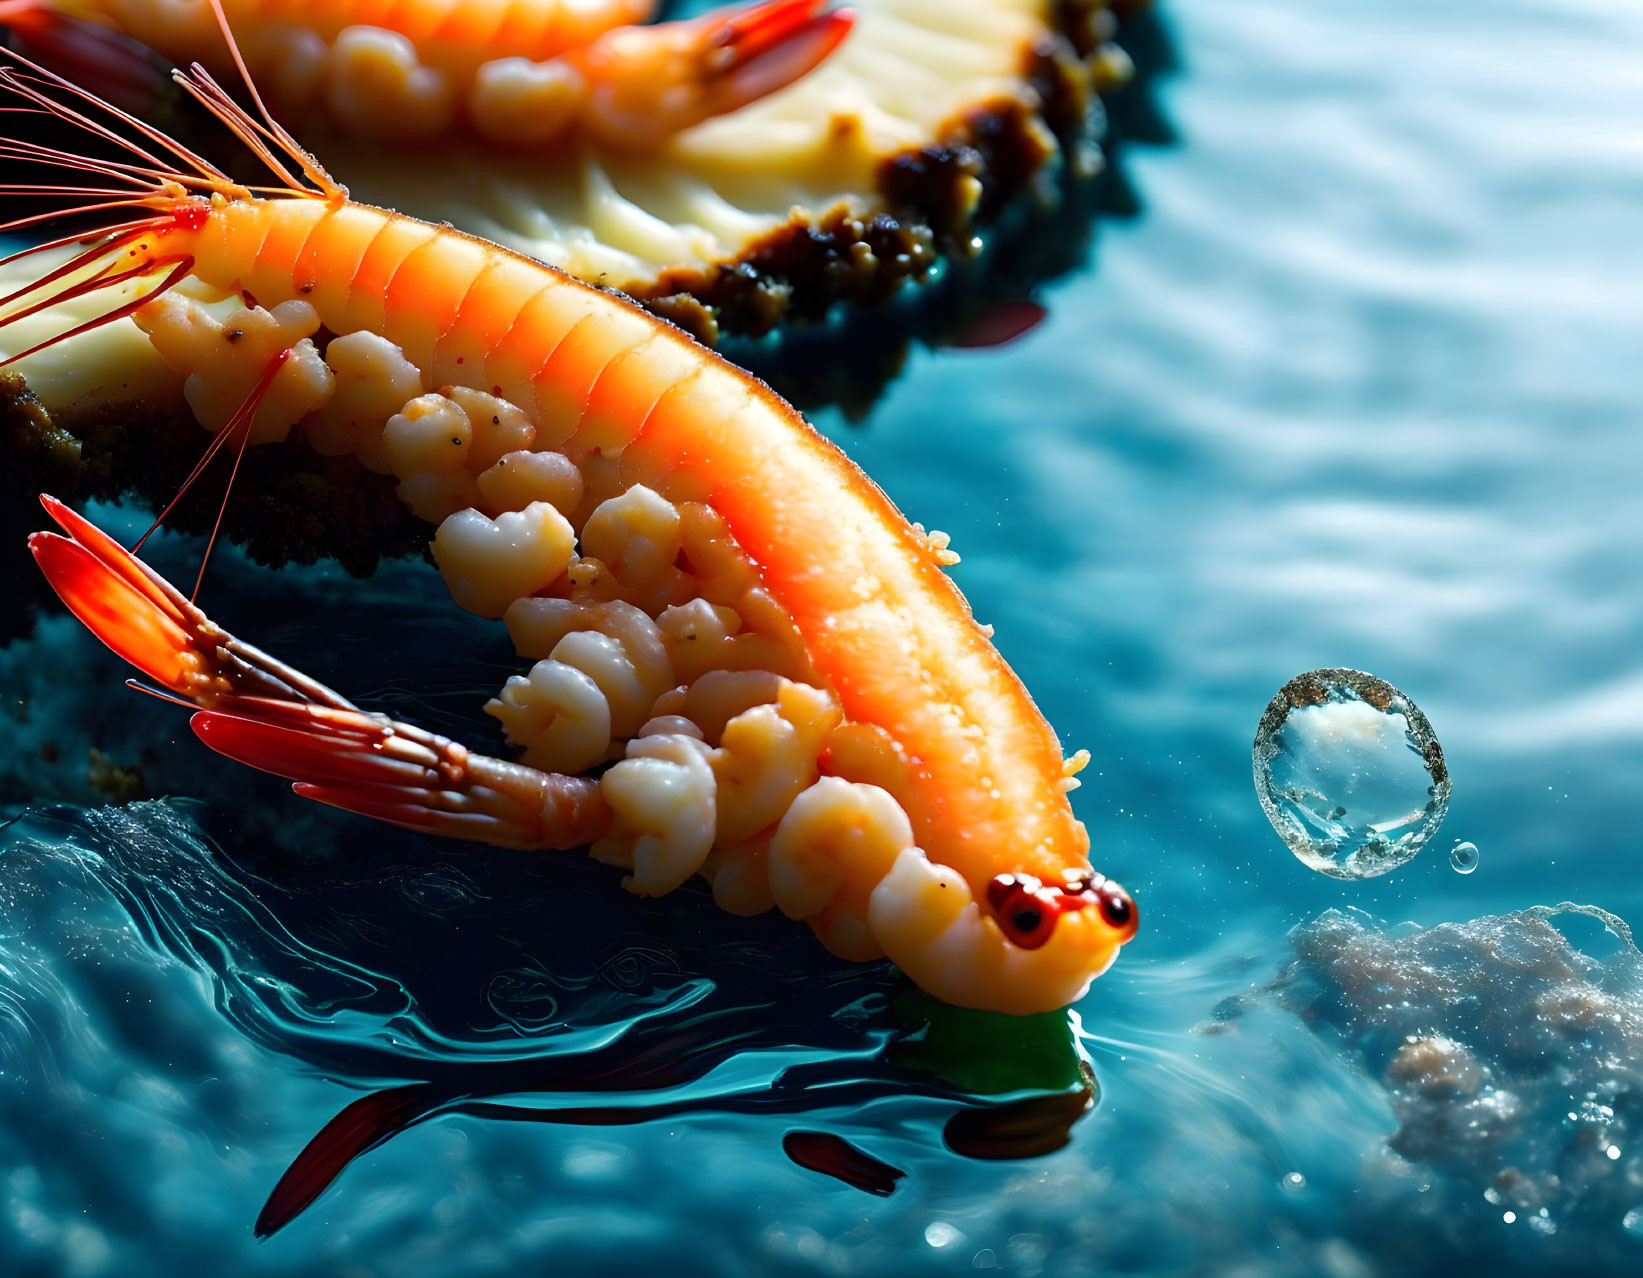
[623,0,1148,345]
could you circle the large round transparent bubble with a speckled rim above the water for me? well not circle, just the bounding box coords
[1254,670,1449,879]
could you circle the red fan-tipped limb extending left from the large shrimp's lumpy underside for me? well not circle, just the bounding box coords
[28,496,611,849]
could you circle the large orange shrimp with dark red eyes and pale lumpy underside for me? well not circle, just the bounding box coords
[0,7,1137,1014]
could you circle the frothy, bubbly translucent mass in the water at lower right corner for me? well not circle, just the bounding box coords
[1273,902,1643,1271]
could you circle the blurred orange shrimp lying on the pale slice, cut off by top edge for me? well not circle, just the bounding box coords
[0,0,854,149]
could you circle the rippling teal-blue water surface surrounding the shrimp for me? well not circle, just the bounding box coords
[0,0,1643,1278]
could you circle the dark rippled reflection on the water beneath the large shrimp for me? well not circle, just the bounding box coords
[5,803,1096,1235]
